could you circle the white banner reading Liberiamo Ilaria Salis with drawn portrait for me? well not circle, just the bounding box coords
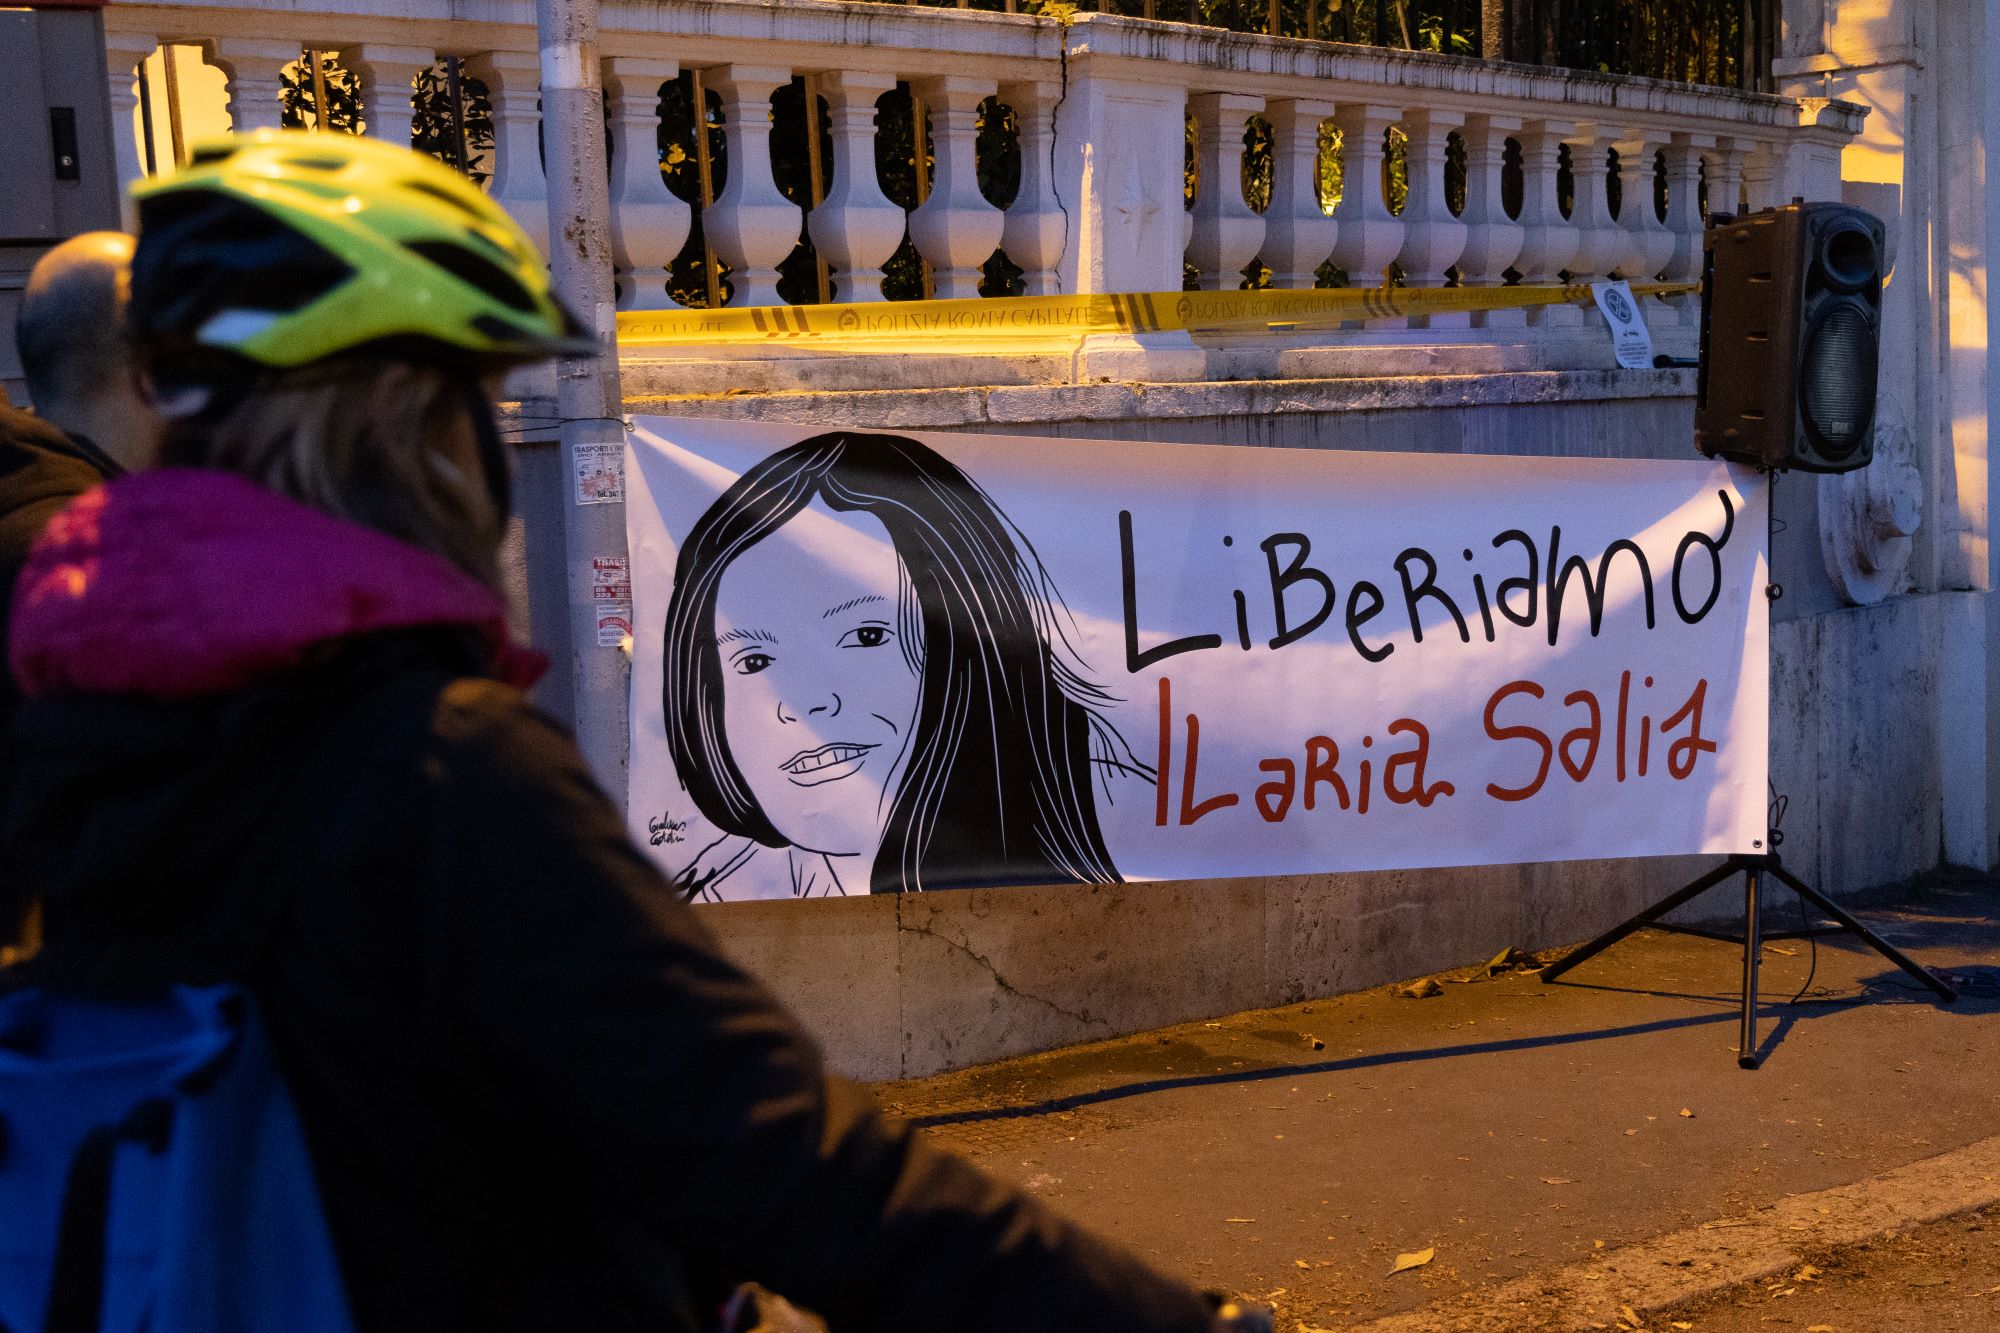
[626,416,1768,901]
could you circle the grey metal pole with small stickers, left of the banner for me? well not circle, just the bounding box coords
[534,0,632,807]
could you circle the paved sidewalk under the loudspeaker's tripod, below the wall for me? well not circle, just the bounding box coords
[878,879,2000,1333]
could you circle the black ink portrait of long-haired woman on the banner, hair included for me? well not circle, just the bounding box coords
[664,432,1154,899]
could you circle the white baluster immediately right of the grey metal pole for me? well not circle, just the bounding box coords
[604,56,694,310]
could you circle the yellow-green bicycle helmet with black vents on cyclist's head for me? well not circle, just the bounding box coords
[130,130,598,380]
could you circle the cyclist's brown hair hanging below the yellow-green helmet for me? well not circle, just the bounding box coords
[160,358,506,588]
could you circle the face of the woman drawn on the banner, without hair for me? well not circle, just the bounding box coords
[716,500,920,860]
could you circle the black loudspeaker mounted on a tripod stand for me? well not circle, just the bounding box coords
[1694,202,1882,472]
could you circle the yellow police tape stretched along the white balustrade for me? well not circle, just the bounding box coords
[618,282,1696,352]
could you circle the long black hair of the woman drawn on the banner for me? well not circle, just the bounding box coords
[664,430,1152,897]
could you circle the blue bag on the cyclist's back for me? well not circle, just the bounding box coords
[0,985,354,1333]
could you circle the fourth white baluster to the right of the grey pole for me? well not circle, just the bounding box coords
[910,74,1006,300]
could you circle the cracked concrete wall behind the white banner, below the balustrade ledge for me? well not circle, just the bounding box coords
[672,386,1952,1079]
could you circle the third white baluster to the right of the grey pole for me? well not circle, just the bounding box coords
[806,70,904,300]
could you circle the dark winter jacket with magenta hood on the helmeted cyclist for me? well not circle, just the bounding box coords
[6,470,1208,1333]
